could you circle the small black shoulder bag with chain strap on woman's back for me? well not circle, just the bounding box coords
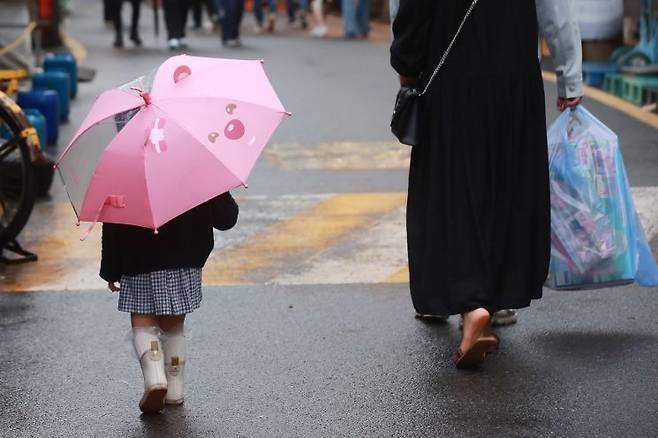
[391,0,478,146]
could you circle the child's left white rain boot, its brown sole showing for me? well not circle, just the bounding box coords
[133,328,167,413]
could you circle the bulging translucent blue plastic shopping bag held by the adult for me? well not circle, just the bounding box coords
[546,105,658,289]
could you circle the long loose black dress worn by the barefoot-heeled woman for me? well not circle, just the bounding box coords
[391,0,550,315]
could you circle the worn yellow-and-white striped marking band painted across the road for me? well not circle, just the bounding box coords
[0,187,658,291]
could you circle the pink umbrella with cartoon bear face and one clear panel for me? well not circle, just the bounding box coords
[56,55,290,240]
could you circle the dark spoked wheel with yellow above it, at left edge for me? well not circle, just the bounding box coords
[0,92,35,248]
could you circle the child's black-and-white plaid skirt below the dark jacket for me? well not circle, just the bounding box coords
[119,268,202,315]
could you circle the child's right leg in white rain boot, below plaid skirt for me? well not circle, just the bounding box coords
[158,315,185,405]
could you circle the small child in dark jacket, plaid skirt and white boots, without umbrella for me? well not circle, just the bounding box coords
[100,192,238,412]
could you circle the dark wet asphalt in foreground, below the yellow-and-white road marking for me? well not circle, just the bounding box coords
[0,285,658,437]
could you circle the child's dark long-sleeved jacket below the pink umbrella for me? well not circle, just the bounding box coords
[100,193,238,282]
